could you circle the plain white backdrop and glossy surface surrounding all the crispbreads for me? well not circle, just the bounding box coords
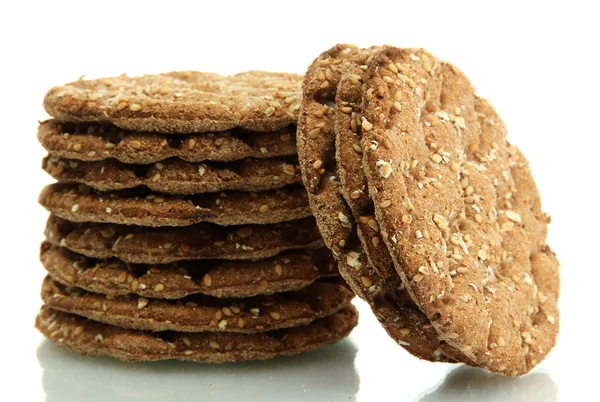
[0,0,600,401]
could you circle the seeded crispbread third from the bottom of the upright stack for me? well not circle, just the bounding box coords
[40,242,338,299]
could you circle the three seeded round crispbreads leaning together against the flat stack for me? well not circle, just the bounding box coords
[298,45,559,375]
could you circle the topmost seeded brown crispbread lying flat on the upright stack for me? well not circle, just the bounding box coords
[44,71,302,134]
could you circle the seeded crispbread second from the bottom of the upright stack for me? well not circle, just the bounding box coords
[42,276,354,333]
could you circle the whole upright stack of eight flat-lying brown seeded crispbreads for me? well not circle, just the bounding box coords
[37,72,357,362]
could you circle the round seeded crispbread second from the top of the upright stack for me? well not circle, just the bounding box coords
[38,120,296,164]
